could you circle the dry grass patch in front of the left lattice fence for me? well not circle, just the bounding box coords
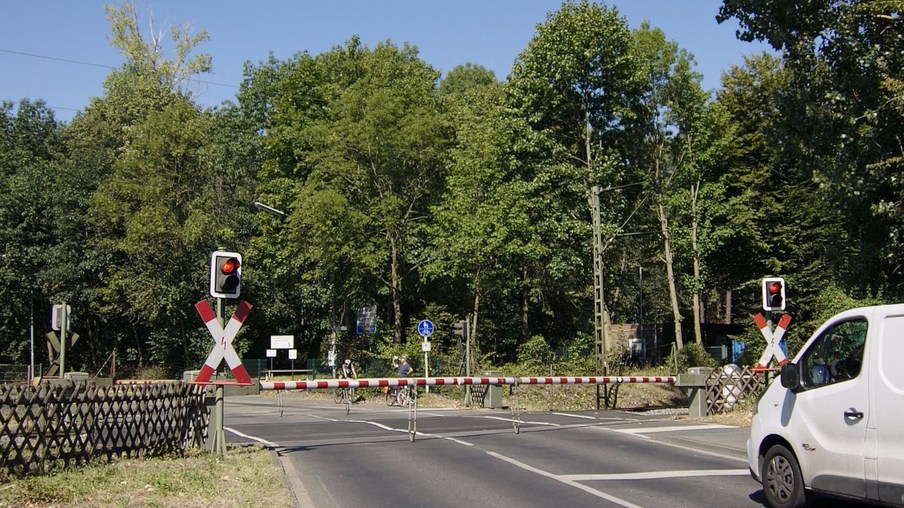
[0,446,292,508]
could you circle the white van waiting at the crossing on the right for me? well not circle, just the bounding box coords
[747,304,904,507]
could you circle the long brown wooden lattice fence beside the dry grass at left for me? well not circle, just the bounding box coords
[0,381,208,478]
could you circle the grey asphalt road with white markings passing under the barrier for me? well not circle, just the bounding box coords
[224,392,764,508]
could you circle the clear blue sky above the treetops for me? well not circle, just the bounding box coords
[0,0,766,121]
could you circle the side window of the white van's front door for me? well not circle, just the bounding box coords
[800,319,867,388]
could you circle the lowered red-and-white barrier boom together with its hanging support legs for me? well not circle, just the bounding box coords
[261,376,677,442]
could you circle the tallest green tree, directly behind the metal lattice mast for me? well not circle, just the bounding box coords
[508,1,641,364]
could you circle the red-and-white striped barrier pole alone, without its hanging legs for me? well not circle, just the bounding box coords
[261,376,677,390]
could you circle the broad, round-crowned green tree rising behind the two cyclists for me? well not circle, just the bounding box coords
[264,39,448,344]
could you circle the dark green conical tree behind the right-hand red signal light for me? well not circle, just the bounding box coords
[715,54,856,334]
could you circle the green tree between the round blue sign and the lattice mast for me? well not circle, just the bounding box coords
[424,80,554,366]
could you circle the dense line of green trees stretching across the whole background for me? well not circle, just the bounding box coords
[0,0,904,374]
